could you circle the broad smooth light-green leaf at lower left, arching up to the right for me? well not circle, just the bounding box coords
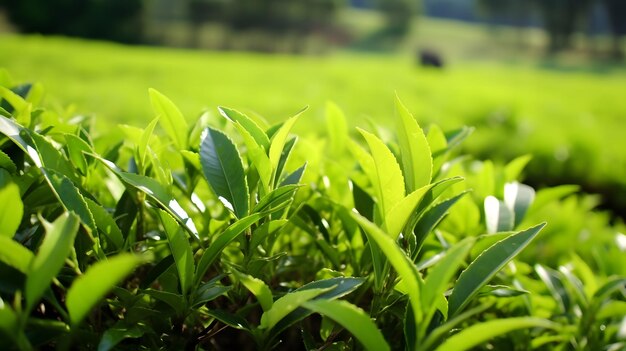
[67,254,142,327]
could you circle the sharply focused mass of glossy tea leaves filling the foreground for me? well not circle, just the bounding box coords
[0,77,626,350]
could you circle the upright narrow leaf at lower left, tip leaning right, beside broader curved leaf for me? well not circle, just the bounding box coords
[25,212,79,310]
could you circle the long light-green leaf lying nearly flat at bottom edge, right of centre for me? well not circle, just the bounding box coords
[435,317,555,351]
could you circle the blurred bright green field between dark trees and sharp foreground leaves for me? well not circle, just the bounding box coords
[0,35,626,219]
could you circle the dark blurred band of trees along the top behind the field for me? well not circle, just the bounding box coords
[0,0,626,58]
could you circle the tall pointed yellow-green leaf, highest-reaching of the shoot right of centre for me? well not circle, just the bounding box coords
[395,95,433,192]
